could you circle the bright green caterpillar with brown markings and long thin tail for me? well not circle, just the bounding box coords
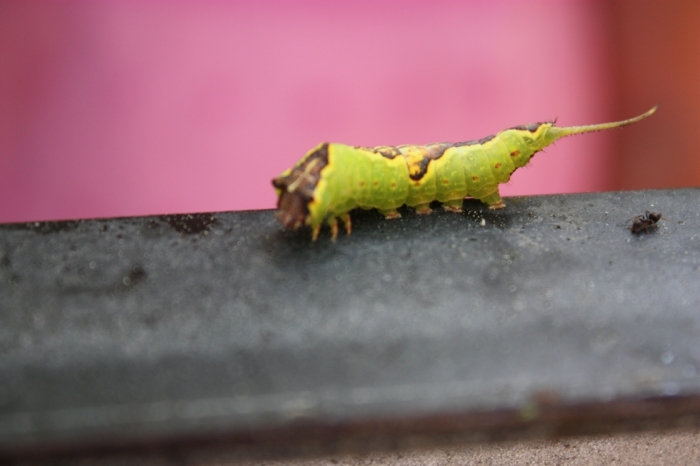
[272,105,659,241]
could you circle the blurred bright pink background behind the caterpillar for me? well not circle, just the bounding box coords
[0,0,700,222]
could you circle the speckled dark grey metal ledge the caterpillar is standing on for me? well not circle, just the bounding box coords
[0,188,700,458]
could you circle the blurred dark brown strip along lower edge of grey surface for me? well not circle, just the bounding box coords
[0,393,700,464]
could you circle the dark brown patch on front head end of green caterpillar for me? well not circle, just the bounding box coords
[272,143,328,229]
